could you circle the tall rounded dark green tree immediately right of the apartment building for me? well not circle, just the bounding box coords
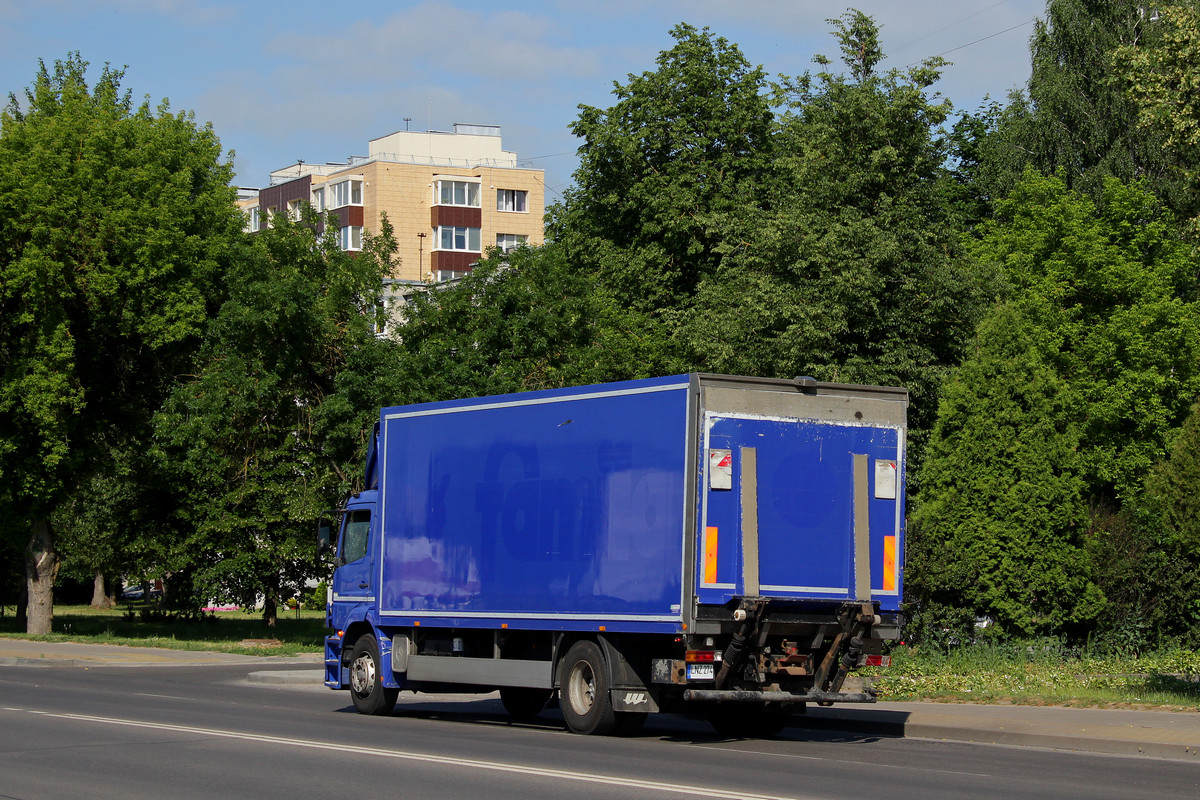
[547,24,772,313]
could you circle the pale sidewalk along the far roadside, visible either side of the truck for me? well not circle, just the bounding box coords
[0,638,1200,763]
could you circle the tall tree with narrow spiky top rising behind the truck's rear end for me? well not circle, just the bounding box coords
[674,12,992,470]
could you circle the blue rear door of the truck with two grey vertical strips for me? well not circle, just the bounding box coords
[695,377,907,610]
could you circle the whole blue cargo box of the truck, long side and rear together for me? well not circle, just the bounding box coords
[350,374,907,632]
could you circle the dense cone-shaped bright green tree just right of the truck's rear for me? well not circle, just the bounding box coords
[906,303,1103,634]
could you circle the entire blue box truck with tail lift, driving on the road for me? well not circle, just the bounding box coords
[318,374,908,735]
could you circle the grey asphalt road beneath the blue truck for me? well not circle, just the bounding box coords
[0,666,1200,800]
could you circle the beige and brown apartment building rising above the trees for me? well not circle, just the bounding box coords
[239,124,546,287]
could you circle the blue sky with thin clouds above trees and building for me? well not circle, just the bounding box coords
[0,0,1045,200]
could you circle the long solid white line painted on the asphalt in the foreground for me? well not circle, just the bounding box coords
[6,709,809,800]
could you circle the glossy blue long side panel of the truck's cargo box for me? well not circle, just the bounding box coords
[379,377,689,622]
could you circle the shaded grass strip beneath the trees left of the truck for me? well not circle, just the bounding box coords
[0,606,325,656]
